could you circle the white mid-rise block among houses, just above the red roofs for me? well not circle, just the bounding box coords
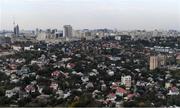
[121,75,131,88]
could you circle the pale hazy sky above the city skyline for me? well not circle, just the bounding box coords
[0,0,180,30]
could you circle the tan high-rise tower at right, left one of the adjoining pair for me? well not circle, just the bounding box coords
[149,56,158,70]
